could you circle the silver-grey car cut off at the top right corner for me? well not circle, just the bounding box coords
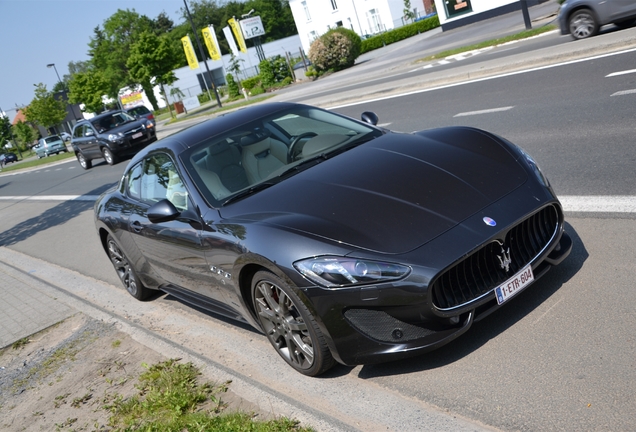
[559,0,636,39]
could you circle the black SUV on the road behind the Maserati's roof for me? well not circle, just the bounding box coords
[71,111,157,169]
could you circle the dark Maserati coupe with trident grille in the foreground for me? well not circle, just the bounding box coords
[95,103,572,376]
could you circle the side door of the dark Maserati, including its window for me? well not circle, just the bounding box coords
[129,153,220,301]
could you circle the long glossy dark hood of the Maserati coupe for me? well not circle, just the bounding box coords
[220,128,527,254]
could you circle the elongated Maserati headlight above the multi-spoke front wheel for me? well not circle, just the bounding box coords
[294,257,411,288]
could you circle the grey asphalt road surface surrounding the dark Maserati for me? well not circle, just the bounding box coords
[0,22,636,431]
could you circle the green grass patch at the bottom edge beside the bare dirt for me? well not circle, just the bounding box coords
[104,359,313,432]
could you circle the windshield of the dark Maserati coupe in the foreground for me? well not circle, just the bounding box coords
[182,106,382,206]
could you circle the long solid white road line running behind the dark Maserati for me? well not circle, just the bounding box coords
[0,195,636,213]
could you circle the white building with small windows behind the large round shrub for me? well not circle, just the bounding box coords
[289,0,426,53]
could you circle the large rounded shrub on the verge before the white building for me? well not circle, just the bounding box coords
[308,31,356,74]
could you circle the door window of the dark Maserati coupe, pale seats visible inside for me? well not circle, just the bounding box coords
[140,154,188,210]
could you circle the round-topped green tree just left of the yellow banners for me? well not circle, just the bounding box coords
[126,31,180,117]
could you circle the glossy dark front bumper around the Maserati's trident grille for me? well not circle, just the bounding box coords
[303,191,572,365]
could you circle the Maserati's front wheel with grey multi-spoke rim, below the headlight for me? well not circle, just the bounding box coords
[252,271,335,376]
